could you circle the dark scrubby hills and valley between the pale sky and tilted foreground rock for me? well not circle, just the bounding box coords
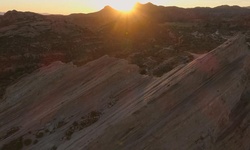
[0,3,250,101]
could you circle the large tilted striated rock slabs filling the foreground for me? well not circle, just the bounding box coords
[0,35,250,150]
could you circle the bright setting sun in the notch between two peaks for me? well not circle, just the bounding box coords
[110,0,137,13]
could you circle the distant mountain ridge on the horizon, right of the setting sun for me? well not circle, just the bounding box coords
[131,3,250,22]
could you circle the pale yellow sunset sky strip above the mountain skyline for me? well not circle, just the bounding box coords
[0,0,250,15]
